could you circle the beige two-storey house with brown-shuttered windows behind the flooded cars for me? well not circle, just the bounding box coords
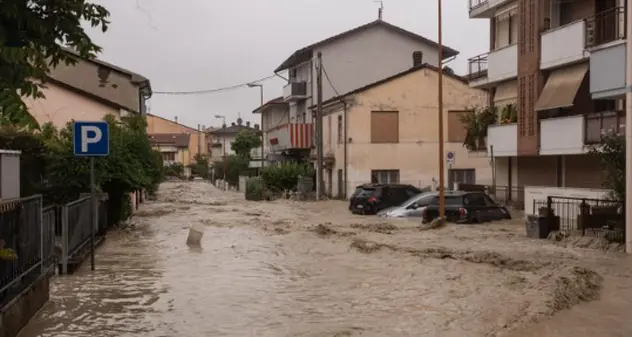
[323,64,492,197]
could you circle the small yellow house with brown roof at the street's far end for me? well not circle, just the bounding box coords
[148,133,191,165]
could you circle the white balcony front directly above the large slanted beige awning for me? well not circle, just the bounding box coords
[540,20,589,69]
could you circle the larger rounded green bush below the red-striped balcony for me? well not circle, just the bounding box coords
[261,162,313,192]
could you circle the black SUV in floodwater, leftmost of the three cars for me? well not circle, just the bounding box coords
[349,184,422,214]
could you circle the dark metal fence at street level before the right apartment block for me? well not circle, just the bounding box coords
[532,196,625,242]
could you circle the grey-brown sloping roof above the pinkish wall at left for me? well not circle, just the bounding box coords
[47,48,151,113]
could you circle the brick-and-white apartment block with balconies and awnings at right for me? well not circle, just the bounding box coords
[468,0,626,211]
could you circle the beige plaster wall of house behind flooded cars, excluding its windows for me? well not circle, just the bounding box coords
[323,69,492,196]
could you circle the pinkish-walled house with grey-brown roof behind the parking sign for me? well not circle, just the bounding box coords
[25,50,152,128]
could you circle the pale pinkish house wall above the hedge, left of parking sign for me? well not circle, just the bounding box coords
[24,83,120,128]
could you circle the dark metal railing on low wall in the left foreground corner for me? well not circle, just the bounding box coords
[0,195,54,303]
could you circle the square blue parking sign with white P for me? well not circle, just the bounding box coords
[72,121,110,157]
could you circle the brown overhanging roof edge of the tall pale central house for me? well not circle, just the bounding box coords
[274,19,459,73]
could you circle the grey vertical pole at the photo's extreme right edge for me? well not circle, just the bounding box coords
[625,0,632,254]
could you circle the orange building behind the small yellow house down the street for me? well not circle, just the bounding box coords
[147,114,209,166]
